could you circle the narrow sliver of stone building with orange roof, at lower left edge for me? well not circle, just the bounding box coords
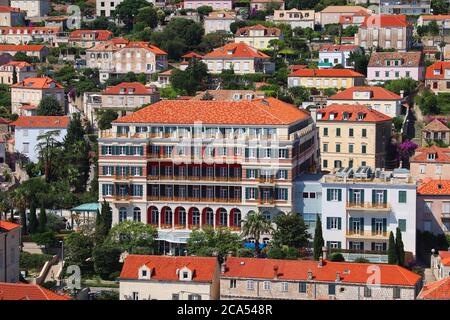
[0,220,21,282]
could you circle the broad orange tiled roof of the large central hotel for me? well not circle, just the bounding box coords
[114,98,310,125]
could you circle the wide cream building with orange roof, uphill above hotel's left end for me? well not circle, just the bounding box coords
[86,40,168,82]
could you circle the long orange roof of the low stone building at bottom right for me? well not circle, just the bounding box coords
[222,257,421,286]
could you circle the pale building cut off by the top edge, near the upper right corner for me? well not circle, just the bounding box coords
[380,0,431,16]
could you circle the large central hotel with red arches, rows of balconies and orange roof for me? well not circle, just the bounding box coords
[99,98,319,250]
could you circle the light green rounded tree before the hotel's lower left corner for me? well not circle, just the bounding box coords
[105,220,157,254]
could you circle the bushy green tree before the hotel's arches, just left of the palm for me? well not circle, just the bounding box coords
[186,227,243,257]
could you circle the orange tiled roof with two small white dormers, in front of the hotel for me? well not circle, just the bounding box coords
[120,254,218,282]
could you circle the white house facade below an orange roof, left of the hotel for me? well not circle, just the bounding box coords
[14,127,67,163]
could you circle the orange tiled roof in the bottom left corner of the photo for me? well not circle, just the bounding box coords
[0,282,71,300]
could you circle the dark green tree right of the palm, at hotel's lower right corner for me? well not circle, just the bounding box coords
[273,213,310,248]
